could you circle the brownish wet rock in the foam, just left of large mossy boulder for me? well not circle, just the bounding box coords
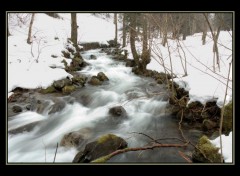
[60,128,92,147]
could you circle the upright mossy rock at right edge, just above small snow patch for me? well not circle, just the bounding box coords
[222,102,233,135]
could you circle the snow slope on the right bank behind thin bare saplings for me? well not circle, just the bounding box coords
[147,31,232,107]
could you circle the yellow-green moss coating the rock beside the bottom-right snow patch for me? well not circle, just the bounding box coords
[197,136,221,163]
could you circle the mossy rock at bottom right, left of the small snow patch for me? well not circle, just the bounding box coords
[192,136,221,163]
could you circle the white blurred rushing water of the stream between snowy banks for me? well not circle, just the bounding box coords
[8,50,201,163]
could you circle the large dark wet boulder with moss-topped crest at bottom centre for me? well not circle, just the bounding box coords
[73,134,127,163]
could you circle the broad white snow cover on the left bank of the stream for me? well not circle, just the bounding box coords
[8,13,114,92]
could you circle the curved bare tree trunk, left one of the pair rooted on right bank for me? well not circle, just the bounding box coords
[130,13,139,65]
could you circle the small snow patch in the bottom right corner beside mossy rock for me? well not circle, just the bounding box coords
[211,132,232,163]
